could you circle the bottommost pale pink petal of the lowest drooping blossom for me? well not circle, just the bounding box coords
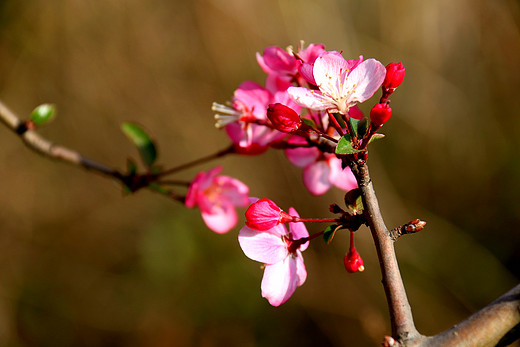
[261,257,299,306]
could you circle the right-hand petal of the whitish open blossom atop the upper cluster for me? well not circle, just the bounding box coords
[343,59,386,103]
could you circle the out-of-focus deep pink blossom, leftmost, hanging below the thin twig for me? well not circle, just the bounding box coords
[185,166,249,234]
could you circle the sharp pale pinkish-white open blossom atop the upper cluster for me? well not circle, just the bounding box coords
[288,52,386,115]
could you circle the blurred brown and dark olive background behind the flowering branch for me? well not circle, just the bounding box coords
[0,0,520,347]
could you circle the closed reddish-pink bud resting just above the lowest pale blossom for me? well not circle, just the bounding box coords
[246,199,294,231]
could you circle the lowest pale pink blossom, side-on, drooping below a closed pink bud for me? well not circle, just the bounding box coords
[238,207,309,306]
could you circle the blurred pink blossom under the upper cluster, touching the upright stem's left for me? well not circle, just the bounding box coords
[285,136,357,195]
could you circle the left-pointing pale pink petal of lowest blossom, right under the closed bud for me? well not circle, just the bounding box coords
[238,226,288,264]
